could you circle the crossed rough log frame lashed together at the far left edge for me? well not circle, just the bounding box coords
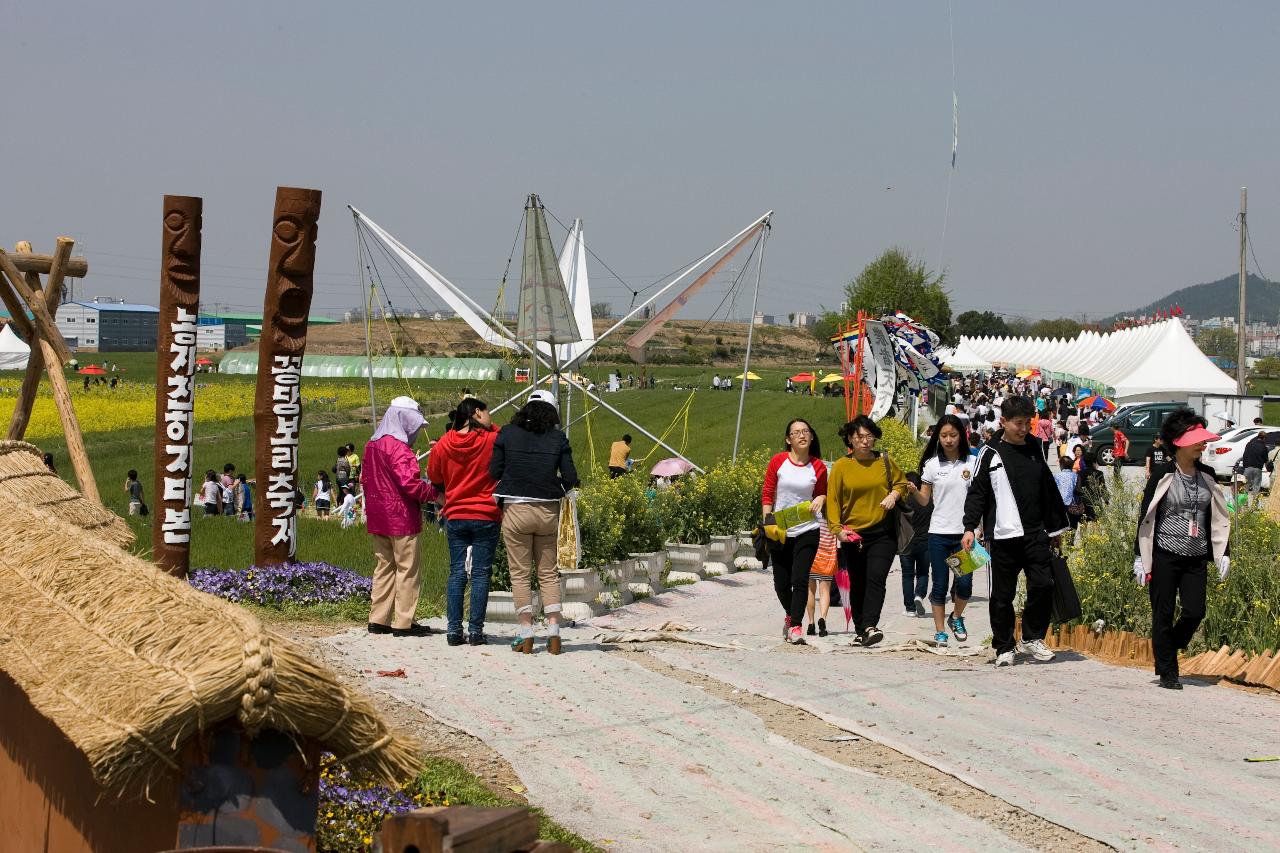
[0,237,101,503]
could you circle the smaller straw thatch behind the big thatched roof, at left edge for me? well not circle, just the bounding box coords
[0,441,133,548]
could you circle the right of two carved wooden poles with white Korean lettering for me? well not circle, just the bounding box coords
[253,187,320,566]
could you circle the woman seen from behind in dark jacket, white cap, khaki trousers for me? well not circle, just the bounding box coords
[489,391,579,654]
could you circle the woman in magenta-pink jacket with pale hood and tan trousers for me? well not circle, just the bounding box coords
[360,397,431,637]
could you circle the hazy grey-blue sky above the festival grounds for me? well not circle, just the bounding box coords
[0,0,1280,319]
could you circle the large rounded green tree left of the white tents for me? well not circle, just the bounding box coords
[845,246,951,339]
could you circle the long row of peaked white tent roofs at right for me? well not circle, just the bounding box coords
[947,319,1235,401]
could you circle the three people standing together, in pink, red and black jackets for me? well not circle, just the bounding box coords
[361,391,579,654]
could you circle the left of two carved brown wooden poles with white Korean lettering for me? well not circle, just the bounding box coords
[151,196,204,578]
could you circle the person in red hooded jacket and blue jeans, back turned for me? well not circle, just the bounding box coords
[426,397,502,646]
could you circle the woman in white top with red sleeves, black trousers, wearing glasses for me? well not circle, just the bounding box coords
[760,418,831,646]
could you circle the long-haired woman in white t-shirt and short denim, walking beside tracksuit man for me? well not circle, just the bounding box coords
[908,415,973,646]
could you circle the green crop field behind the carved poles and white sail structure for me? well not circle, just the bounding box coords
[24,352,865,596]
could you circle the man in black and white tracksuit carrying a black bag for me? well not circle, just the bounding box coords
[964,397,1070,666]
